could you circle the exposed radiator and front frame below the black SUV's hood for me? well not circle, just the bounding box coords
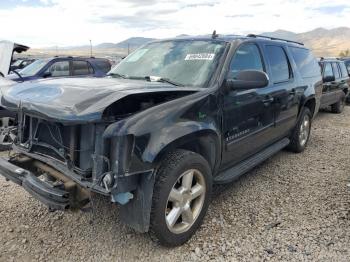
[0,114,142,209]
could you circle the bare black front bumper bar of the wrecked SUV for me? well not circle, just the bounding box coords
[0,158,69,210]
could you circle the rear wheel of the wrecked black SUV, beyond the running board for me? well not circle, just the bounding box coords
[288,107,312,153]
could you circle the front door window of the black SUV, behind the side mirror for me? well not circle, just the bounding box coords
[227,44,264,79]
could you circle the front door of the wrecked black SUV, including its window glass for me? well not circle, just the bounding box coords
[222,43,274,167]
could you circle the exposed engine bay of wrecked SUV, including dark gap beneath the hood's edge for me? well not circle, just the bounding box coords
[5,91,196,209]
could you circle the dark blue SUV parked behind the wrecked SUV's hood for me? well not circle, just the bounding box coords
[7,57,111,82]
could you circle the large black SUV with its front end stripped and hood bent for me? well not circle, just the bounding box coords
[0,34,322,246]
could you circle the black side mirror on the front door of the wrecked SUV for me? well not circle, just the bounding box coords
[226,70,269,90]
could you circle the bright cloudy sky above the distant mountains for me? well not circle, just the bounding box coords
[0,0,350,48]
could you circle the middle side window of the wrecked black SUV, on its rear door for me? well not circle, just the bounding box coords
[266,45,291,83]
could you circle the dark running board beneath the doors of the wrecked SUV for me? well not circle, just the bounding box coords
[214,138,290,184]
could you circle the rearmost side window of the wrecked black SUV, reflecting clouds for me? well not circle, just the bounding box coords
[290,47,320,78]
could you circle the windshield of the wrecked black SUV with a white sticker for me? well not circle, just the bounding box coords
[109,40,226,87]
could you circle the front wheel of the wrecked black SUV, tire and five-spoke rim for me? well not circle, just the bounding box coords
[149,150,212,247]
